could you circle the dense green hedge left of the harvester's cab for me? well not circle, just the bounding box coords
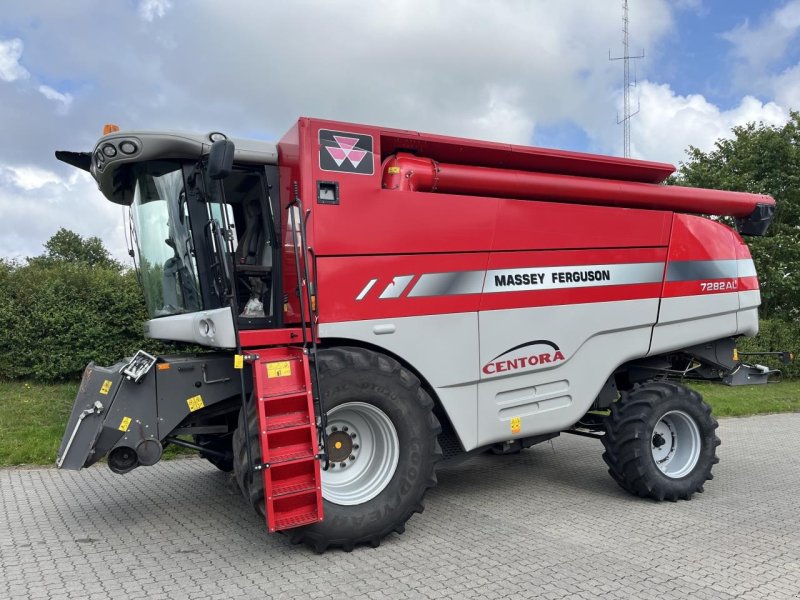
[0,261,152,381]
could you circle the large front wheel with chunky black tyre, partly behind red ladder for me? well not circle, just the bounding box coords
[233,348,441,552]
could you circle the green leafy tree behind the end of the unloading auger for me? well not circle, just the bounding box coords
[672,112,800,319]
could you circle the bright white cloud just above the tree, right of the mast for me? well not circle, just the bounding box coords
[631,81,789,164]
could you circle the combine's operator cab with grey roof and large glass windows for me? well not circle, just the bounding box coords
[57,132,282,348]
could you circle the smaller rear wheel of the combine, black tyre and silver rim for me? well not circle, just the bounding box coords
[602,381,720,502]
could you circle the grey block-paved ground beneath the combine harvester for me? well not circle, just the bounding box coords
[0,414,800,599]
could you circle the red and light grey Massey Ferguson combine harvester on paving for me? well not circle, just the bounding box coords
[56,118,774,550]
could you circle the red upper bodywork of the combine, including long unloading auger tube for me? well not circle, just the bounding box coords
[279,119,773,323]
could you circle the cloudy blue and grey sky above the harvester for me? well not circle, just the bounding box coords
[0,0,800,257]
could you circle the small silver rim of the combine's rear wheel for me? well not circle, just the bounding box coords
[650,410,701,479]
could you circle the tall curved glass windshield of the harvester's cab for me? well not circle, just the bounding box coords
[131,161,203,318]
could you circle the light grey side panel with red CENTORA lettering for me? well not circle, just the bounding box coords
[478,299,658,445]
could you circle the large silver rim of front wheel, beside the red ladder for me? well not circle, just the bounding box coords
[322,402,400,506]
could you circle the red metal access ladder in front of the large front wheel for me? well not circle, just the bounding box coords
[250,346,322,533]
